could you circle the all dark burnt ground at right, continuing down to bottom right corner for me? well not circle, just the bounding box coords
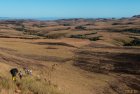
[73,47,140,94]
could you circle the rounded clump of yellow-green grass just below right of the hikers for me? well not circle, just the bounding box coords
[17,77,60,94]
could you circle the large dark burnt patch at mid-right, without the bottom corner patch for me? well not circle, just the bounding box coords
[74,47,140,74]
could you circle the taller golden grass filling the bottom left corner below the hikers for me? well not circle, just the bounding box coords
[0,64,62,94]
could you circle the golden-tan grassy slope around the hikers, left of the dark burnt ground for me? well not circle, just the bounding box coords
[0,39,124,94]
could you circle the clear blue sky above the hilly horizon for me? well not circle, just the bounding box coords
[0,0,140,18]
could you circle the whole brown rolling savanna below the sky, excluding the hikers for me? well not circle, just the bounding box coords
[0,15,140,94]
